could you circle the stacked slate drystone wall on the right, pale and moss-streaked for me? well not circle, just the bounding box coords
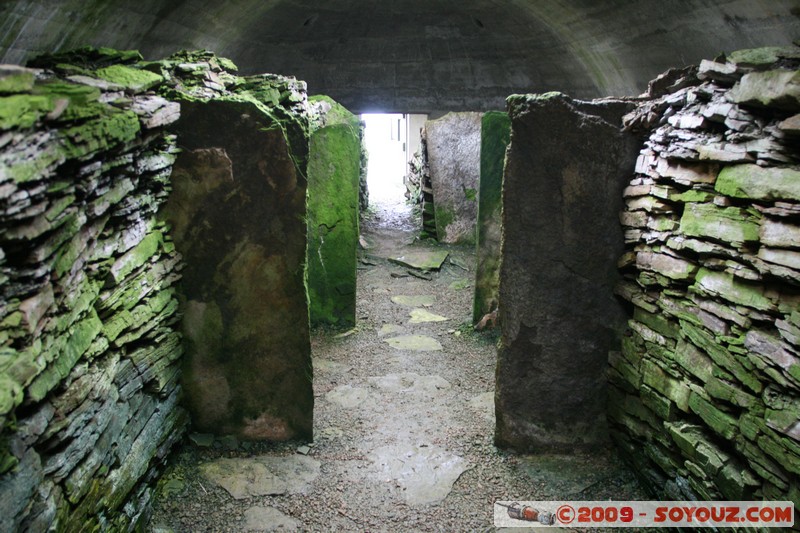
[609,48,800,508]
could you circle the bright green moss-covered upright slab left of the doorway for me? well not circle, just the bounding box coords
[308,99,361,326]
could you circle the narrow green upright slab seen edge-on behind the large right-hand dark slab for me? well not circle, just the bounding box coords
[472,111,511,323]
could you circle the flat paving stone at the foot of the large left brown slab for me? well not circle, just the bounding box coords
[200,455,320,500]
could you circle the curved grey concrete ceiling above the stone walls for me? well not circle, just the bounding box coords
[0,0,800,112]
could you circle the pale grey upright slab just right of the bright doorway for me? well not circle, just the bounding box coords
[425,113,482,244]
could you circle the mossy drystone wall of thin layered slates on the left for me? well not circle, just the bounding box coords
[0,50,188,531]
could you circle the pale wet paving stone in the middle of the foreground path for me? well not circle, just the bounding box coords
[369,445,468,506]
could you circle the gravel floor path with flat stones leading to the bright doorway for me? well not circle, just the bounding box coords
[151,201,647,532]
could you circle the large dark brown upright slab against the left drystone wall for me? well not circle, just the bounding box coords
[162,96,314,440]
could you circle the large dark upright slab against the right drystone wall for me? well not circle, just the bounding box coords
[495,93,637,451]
